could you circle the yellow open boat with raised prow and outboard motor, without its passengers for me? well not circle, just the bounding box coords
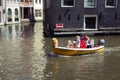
[53,38,105,56]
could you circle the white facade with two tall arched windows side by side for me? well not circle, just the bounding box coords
[5,0,20,24]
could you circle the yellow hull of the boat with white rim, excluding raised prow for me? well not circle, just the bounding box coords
[53,46,104,56]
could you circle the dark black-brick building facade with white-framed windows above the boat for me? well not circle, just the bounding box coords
[44,0,120,34]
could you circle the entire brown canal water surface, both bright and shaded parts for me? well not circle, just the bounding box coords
[0,23,120,80]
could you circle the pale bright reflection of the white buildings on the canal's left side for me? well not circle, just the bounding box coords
[0,23,46,80]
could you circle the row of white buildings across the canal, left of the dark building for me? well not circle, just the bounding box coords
[0,0,43,25]
